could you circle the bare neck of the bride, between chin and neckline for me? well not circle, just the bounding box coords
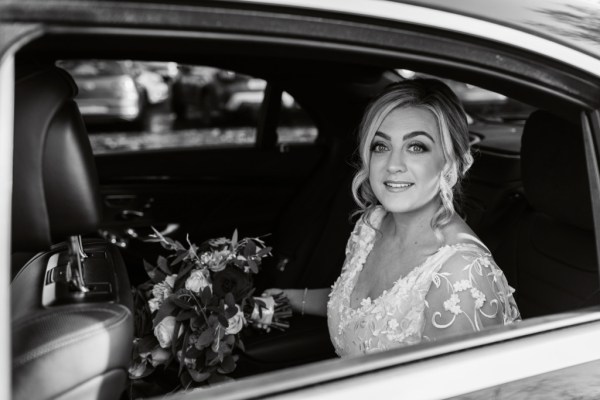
[382,198,440,247]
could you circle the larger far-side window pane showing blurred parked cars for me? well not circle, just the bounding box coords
[57,60,266,154]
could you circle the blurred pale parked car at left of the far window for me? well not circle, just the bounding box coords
[63,60,148,123]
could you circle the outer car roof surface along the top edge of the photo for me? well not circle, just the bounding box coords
[0,0,600,59]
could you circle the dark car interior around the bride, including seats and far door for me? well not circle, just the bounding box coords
[11,22,600,399]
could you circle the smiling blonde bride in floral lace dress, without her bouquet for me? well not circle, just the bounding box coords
[264,79,520,356]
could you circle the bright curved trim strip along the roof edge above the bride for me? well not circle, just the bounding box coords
[237,0,600,77]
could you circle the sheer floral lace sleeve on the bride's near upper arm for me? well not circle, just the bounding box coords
[423,251,520,340]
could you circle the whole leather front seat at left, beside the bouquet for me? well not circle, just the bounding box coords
[11,66,133,400]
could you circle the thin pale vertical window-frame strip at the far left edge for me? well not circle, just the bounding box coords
[0,50,15,399]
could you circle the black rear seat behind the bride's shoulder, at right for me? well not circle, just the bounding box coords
[492,111,598,317]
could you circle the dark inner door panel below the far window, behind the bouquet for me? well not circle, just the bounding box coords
[96,145,327,241]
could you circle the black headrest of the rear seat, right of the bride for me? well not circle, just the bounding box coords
[521,110,593,230]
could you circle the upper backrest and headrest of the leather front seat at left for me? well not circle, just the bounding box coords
[12,67,101,252]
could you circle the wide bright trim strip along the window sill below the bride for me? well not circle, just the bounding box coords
[270,323,600,400]
